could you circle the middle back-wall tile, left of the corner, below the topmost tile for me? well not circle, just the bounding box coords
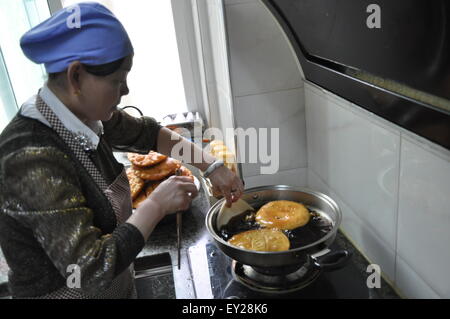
[234,89,307,177]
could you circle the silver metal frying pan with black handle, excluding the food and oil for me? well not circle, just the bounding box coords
[206,185,350,273]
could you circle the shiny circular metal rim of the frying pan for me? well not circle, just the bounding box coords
[205,185,342,256]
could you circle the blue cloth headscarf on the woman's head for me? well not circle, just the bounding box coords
[20,2,133,73]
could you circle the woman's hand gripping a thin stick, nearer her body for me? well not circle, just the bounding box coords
[147,176,198,216]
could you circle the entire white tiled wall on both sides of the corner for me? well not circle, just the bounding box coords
[225,0,450,298]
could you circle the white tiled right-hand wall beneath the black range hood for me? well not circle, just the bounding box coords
[305,83,450,298]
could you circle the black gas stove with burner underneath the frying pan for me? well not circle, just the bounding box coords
[188,235,398,299]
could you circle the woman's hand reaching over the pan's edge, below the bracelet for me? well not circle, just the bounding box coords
[209,166,244,207]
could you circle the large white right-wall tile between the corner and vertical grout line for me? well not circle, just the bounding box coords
[305,85,400,268]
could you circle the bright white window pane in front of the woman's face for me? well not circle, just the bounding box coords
[62,0,187,120]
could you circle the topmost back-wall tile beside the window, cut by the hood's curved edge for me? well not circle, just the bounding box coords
[225,1,303,96]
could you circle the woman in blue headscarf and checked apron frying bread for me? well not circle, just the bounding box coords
[0,3,243,298]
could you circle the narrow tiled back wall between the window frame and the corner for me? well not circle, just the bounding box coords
[224,0,307,187]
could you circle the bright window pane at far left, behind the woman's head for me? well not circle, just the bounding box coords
[0,0,50,131]
